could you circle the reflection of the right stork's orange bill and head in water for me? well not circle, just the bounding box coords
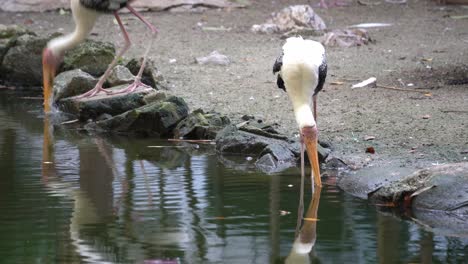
[285,186,322,264]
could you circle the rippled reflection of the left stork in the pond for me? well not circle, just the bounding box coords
[42,119,121,263]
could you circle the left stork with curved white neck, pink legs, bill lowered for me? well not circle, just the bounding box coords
[42,0,157,112]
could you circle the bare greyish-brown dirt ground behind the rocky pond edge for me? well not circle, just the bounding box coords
[0,0,468,167]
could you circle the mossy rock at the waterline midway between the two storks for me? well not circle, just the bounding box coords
[174,109,230,139]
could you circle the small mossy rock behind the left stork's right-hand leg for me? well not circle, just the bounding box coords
[126,59,169,90]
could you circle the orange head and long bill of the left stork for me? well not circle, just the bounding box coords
[42,47,63,113]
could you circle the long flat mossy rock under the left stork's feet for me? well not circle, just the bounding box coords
[57,85,154,121]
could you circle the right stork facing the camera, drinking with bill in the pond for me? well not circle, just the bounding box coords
[273,37,327,204]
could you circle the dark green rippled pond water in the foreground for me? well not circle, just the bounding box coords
[0,93,468,263]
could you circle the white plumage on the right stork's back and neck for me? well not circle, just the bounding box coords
[281,37,325,128]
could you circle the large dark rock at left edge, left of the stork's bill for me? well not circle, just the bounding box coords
[0,31,48,86]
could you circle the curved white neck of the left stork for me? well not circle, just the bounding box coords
[47,0,98,55]
